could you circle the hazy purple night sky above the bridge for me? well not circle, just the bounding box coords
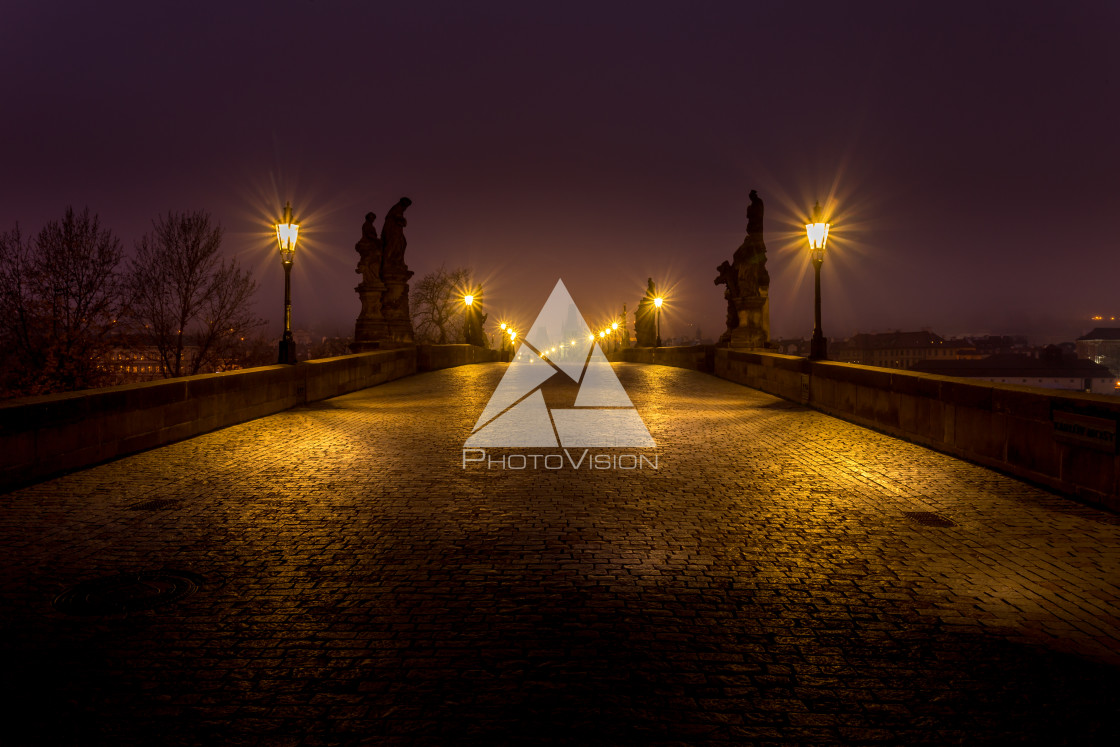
[0,0,1120,342]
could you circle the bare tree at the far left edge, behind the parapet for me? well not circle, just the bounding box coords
[0,207,125,396]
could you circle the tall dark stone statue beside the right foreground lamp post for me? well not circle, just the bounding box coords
[715,189,769,347]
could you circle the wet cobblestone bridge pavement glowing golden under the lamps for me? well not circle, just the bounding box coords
[0,364,1120,745]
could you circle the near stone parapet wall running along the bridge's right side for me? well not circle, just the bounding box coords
[715,348,1120,511]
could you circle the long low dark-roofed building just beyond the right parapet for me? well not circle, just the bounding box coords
[913,346,1116,394]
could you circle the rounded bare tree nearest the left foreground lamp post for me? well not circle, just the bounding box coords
[129,211,262,377]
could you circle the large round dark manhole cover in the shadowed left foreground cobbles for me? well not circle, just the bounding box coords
[55,570,205,615]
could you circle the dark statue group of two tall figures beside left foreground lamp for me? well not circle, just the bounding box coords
[351,197,413,353]
